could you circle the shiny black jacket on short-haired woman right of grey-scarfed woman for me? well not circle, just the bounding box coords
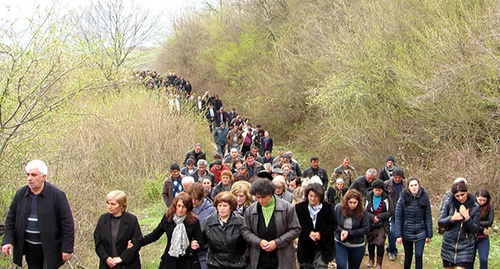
[202,211,248,268]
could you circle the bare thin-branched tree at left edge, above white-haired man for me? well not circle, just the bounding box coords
[0,5,92,165]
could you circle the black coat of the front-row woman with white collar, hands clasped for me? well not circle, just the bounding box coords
[295,201,337,264]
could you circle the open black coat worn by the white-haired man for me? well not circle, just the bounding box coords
[2,181,75,268]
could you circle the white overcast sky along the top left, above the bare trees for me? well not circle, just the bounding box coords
[0,0,207,45]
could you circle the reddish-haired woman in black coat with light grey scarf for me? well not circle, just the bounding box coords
[136,192,204,269]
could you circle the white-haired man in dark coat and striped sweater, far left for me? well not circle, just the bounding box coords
[2,160,75,269]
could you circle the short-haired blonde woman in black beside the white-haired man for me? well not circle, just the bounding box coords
[94,190,142,269]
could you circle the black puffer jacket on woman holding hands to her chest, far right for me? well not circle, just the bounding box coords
[439,193,481,263]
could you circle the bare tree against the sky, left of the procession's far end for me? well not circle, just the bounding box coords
[74,0,161,81]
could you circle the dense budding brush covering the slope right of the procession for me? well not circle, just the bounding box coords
[161,0,500,205]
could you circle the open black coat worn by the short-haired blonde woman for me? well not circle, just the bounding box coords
[94,212,142,269]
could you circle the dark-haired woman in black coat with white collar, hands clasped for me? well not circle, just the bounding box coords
[295,183,337,268]
